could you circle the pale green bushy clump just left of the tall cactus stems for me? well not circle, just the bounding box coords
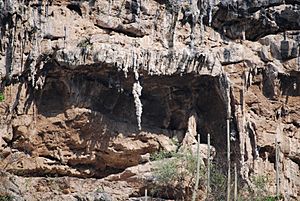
[151,150,206,200]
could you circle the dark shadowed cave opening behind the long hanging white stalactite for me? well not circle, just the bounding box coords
[38,66,226,163]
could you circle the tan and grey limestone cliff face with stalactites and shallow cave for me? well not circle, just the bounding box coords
[0,0,300,200]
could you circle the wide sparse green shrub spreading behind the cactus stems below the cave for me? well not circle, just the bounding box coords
[151,150,227,200]
